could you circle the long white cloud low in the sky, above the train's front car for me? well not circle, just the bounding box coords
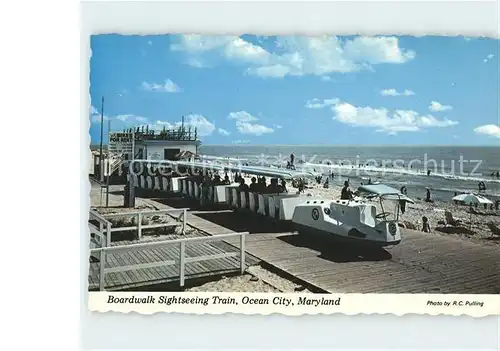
[332,103,458,134]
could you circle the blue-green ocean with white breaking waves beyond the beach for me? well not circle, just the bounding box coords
[199,145,500,201]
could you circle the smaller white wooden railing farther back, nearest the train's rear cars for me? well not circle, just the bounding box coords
[103,208,188,239]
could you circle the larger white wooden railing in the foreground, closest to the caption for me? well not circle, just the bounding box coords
[90,232,248,291]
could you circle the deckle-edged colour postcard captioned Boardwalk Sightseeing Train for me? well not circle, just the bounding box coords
[88,33,500,317]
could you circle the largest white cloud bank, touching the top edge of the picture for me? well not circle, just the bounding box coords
[170,35,415,80]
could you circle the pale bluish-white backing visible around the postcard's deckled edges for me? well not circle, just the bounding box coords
[80,1,499,349]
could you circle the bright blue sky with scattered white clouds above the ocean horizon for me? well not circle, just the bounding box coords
[89,35,500,145]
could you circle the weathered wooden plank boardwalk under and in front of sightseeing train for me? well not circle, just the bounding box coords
[147,199,500,294]
